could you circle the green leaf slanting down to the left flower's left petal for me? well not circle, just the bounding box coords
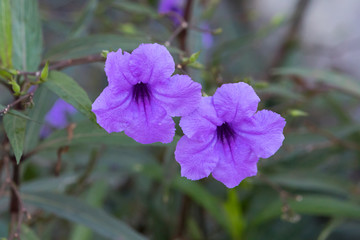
[44,71,96,122]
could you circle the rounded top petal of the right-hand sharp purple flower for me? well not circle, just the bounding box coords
[213,82,260,122]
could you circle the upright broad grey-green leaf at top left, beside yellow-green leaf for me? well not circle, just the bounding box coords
[11,0,42,71]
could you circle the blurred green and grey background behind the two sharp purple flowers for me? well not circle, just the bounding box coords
[0,0,360,240]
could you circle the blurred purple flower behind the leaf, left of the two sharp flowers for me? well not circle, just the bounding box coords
[40,99,76,137]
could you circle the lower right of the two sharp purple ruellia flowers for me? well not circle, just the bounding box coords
[175,83,285,188]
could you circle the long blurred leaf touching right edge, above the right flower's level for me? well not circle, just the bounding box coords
[274,67,360,97]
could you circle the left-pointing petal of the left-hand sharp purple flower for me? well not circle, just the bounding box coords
[92,87,132,133]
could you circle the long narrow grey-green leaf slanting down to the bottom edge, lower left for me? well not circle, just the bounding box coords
[22,192,145,240]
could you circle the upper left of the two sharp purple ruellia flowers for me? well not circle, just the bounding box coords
[92,44,201,144]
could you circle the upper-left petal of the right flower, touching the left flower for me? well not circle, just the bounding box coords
[180,97,222,141]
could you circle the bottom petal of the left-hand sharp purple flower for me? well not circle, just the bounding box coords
[125,101,175,144]
